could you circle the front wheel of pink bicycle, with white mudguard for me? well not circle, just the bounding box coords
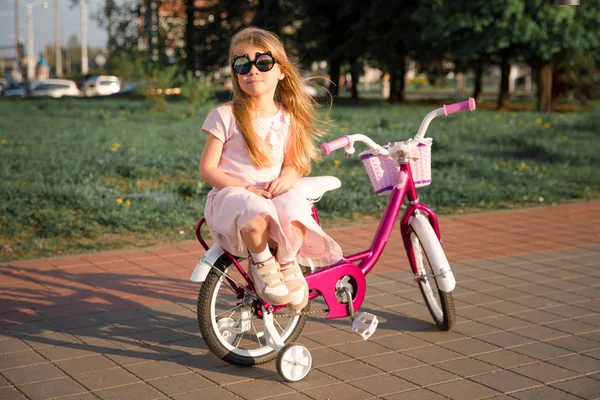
[410,217,456,331]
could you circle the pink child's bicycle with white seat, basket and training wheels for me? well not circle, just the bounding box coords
[191,99,475,381]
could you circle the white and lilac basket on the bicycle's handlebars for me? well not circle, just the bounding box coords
[359,140,431,196]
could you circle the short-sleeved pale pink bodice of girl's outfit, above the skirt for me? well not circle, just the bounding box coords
[202,103,291,184]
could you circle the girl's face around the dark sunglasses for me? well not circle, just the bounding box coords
[233,44,285,99]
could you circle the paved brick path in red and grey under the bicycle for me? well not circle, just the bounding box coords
[0,201,600,400]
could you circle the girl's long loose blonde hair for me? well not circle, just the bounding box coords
[229,27,325,175]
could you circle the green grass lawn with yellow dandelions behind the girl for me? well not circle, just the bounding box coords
[0,99,600,260]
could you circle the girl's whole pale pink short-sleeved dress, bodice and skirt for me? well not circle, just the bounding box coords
[202,103,342,266]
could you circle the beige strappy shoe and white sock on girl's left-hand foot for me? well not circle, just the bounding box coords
[250,257,292,304]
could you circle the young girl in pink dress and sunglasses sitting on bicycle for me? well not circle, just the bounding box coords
[200,27,342,311]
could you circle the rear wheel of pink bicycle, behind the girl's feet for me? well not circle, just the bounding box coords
[197,256,310,366]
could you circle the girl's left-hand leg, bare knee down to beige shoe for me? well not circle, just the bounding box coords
[240,215,291,304]
